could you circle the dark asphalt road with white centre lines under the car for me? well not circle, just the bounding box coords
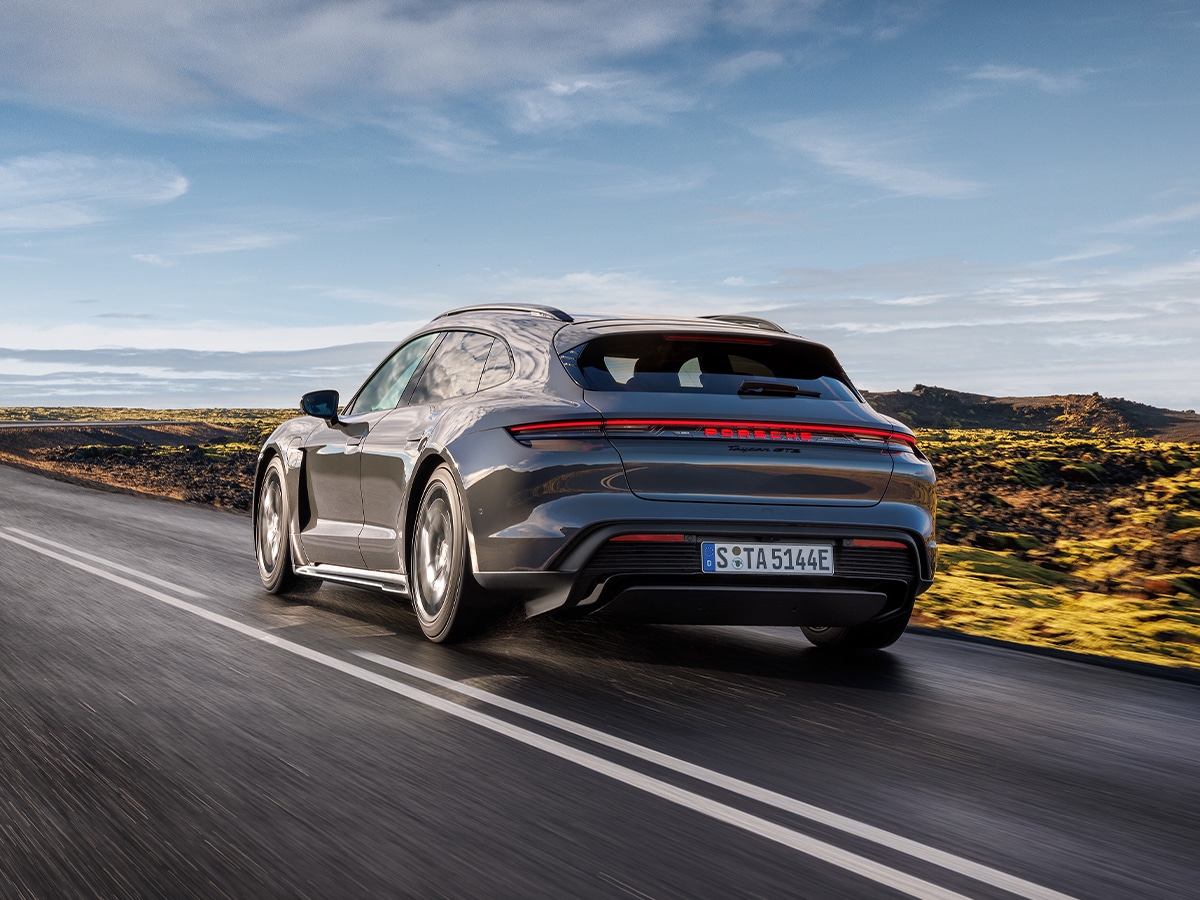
[0,467,1200,899]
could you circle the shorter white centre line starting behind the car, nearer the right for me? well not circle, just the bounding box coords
[354,650,1070,900]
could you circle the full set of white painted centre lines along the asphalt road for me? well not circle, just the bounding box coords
[0,528,1072,900]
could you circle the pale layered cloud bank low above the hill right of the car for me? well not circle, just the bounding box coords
[746,258,1200,409]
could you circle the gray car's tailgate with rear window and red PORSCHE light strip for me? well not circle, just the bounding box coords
[564,332,893,506]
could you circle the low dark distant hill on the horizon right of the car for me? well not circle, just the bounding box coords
[863,384,1200,442]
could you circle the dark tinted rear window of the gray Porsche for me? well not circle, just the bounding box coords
[562,332,859,401]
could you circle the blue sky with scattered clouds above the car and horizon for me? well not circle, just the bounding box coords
[0,0,1200,409]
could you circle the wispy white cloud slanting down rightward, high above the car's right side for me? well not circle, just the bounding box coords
[760,119,982,199]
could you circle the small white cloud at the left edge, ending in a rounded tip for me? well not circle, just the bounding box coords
[0,154,187,232]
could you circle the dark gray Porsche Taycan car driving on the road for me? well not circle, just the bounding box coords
[254,306,937,648]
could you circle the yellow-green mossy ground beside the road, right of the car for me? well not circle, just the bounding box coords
[916,430,1200,667]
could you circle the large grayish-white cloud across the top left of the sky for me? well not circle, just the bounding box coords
[0,0,712,115]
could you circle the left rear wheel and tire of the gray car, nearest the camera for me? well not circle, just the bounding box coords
[408,464,486,643]
